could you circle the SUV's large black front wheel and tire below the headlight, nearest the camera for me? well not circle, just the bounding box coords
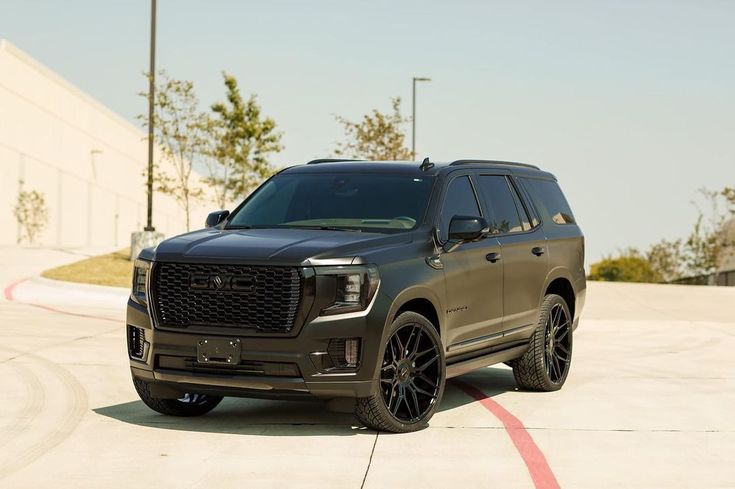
[355,312,446,433]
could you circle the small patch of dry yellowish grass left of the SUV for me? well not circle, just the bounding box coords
[41,248,133,287]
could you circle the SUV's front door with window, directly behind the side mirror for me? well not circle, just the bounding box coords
[438,174,503,356]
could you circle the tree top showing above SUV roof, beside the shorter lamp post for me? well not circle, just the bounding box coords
[334,97,413,160]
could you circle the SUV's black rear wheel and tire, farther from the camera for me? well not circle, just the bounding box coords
[510,294,572,392]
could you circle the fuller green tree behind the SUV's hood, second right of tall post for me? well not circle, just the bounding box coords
[210,73,283,209]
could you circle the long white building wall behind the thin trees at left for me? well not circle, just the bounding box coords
[0,40,210,247]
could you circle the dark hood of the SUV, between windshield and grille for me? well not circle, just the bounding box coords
[155,228,413,266]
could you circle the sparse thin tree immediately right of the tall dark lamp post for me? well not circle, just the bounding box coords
[138,71,210,231]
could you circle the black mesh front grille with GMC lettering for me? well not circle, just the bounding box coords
[151,263,304,332]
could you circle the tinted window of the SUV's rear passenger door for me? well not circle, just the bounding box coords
[477,175,531,234]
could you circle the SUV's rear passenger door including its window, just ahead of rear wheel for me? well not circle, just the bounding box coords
[475,173,549,340]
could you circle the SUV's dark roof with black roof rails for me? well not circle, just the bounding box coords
[283,159,551,176]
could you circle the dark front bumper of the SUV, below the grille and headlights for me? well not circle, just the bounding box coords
[127,291,390,399]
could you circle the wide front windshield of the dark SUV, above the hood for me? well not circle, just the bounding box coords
[227,173,433,233]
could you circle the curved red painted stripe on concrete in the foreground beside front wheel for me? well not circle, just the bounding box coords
[452,379,559,489]
